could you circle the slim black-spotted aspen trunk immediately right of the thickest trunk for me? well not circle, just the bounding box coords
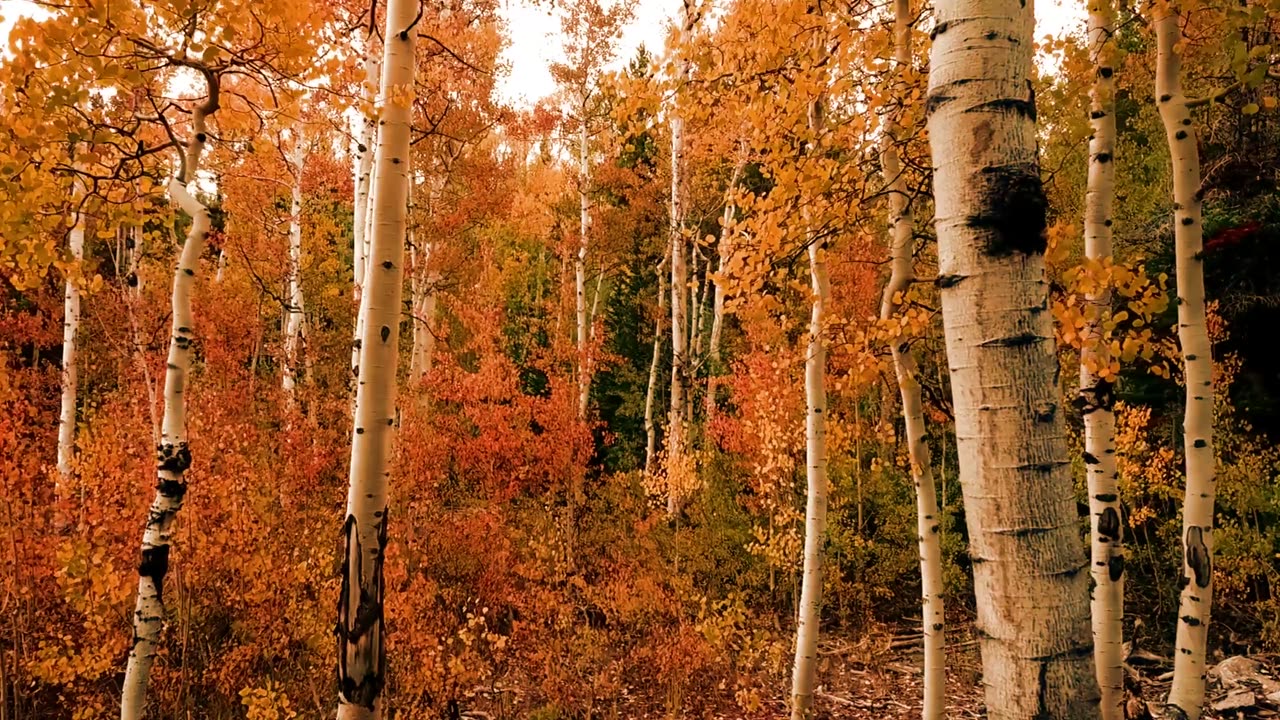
[1076,0,1124,720]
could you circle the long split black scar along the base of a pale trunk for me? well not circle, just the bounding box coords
[334,509,387,710]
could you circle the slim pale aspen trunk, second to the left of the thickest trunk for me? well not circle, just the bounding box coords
[791,100,831,720]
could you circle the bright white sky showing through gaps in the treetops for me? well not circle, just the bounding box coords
[0,0,1085,108]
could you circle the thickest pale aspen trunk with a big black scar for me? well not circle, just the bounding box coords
[927,0,1098,707]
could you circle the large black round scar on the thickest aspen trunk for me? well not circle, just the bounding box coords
[966,163,1048,258]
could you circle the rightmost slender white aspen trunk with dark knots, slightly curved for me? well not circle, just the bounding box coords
[1153,3,1216,720]
